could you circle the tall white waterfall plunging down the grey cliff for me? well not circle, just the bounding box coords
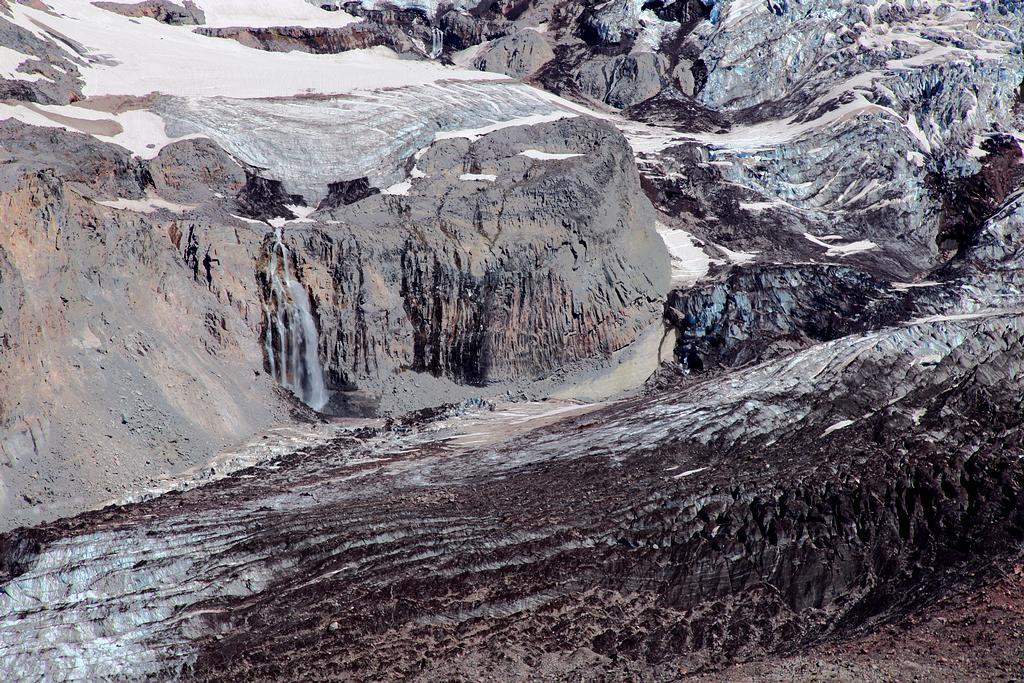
[263,227,328,411]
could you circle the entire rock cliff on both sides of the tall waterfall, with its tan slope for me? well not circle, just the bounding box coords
[0,114,668,524]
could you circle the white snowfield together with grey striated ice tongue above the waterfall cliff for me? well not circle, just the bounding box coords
[0,0,598,192]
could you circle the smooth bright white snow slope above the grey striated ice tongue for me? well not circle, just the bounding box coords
[4,0,507,97]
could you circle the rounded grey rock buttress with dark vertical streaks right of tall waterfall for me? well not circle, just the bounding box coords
[276,118,668,401]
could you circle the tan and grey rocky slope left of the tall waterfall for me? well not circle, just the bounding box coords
[0,122,291,526]
